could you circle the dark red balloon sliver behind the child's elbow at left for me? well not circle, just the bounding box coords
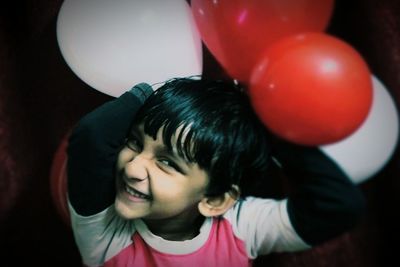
[50,134,71,226]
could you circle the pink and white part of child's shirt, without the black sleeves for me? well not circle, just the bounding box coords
[69,197,309,267]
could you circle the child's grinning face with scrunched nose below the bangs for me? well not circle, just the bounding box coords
[115,125,208,222]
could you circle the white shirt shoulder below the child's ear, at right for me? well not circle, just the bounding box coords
[224,197,309,258]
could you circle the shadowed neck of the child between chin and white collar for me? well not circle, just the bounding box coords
[143,212,205,241]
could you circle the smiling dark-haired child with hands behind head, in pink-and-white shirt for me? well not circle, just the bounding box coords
[67,78,364,267]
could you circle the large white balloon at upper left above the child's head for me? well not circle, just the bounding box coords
[57,0,202,97]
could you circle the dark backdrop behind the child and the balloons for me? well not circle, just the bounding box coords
[0,0,400,267]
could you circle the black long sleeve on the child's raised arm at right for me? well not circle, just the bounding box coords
[275,141,365,245]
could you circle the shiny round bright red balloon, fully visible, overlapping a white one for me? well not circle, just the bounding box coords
[249,33,372,145]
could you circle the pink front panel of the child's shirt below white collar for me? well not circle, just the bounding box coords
[104,219,251,267]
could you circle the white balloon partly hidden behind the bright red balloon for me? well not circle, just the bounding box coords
[320,76,399,184]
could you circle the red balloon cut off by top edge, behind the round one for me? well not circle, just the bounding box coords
[191,0,333,83]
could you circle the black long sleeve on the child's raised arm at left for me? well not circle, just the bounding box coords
[67,83,152,216]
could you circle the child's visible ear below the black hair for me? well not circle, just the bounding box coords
[198,185,240,217]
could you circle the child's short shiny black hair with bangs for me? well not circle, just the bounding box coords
[133,78,270,196]
